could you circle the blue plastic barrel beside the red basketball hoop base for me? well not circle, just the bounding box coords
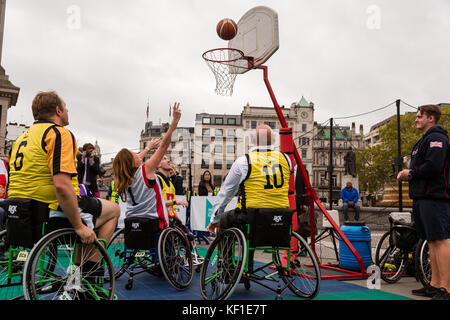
[339,221,372,271]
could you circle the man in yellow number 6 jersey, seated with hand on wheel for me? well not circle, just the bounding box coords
[8,91,120,269]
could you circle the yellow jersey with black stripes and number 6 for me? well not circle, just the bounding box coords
[8,121,80,210]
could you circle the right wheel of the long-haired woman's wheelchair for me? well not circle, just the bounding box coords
[158,228,194,290]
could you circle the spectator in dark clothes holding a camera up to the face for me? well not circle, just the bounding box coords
[77,143,100,198]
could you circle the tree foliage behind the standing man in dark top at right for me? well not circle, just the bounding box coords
[355,108,450,194]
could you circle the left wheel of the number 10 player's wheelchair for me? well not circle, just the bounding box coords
[200,228,247,300]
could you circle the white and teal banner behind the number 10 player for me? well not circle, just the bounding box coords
[190,196,238,231]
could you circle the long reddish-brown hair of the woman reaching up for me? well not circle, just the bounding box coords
[113,148,137,202]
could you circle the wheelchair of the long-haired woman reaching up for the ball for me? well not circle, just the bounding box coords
[108,217,194,290]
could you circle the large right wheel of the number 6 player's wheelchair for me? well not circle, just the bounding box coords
[23,229,115,300]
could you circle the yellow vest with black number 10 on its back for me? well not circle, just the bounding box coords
[237,151,291,208]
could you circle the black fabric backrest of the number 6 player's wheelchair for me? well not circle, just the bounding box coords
[1,198,49,248]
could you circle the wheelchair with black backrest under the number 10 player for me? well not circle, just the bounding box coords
[200,209,321,300]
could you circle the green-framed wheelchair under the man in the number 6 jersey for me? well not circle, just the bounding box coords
[0,199,116,300]
